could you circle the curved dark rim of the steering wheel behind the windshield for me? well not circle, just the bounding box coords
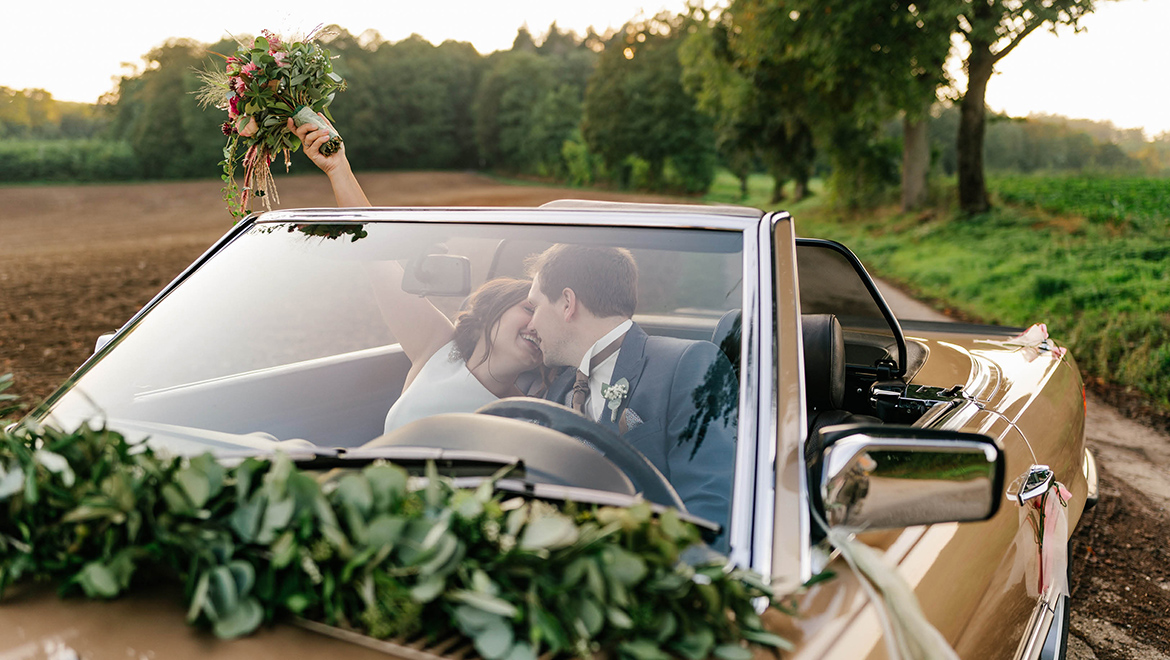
[475,397,687,511]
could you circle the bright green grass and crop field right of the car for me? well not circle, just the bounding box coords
[798,177,1170,407]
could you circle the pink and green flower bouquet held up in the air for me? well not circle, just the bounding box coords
[197,30,345,220]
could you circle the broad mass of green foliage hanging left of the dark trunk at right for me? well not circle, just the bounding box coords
[702,0,955,206]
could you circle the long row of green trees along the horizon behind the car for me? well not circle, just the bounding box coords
[0,0,1151,212]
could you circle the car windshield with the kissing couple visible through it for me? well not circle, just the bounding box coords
[48,212,743,531]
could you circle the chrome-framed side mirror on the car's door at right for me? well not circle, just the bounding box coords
[808,425,1005,529]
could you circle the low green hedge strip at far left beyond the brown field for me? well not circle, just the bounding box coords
[0,139,142,184]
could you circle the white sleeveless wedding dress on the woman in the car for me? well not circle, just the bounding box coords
[384,342,498,433]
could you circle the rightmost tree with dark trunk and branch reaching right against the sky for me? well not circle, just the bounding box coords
[956,0,1096,213]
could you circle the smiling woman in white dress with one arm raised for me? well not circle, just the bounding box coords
[289,119,543,433]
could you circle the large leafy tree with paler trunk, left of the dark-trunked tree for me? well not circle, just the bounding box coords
[724,0,955,206]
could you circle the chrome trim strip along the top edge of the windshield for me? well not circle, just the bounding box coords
[256,206,761,232]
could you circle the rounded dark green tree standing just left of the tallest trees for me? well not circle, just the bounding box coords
[581,15,716,192]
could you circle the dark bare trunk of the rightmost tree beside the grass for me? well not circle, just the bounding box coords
[957,40,995,214]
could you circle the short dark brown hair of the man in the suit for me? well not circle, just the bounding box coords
[527,243,638,317]
